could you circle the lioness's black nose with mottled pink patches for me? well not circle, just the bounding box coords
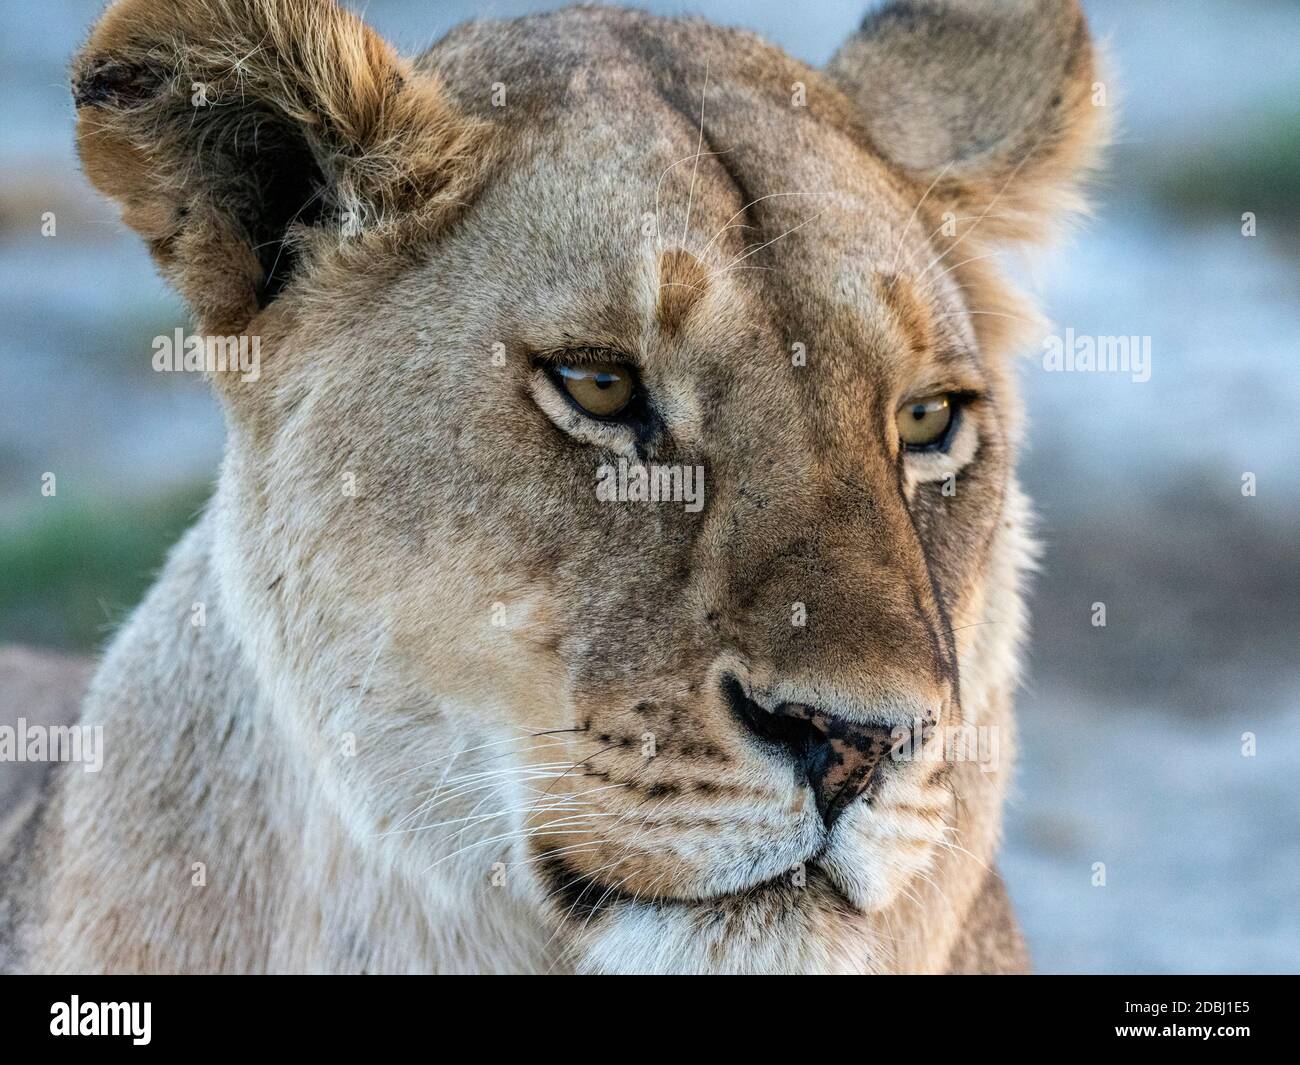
[723,676,913,827]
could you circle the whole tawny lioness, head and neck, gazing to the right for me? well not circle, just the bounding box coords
[0,0,1102,973]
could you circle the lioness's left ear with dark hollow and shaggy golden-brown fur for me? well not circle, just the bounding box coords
[73,0,488,332]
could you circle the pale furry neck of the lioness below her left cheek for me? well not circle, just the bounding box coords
[31,520,549,971]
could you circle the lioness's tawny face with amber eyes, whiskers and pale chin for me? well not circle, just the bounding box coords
[76,3,1091,969]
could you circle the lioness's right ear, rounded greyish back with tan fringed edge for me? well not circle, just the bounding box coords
[828,0,1106,239]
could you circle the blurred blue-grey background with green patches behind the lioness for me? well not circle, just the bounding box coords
[0,0,1300,973]
